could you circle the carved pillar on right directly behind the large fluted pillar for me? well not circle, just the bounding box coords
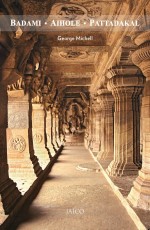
[97,89,114,160]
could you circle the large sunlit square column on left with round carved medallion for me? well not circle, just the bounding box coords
[7,90,38,192]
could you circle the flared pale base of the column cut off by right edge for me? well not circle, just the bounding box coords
[127,170,150,211]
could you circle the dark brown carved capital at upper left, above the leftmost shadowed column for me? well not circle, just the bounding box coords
[0,32,38,85]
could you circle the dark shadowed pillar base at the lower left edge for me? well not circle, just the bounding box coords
[0,178,21,214]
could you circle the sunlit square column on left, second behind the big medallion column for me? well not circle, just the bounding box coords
[32,103,50,169]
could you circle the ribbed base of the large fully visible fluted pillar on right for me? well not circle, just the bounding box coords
[106,160,138,177]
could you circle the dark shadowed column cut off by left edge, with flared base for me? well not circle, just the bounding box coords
[0,85,21,217]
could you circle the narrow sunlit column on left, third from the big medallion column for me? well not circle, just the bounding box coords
[46,109,56,156]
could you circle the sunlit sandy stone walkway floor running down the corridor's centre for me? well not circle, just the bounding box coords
[17,146,137,230]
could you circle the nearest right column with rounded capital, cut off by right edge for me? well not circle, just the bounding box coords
[128,31,150,210]
